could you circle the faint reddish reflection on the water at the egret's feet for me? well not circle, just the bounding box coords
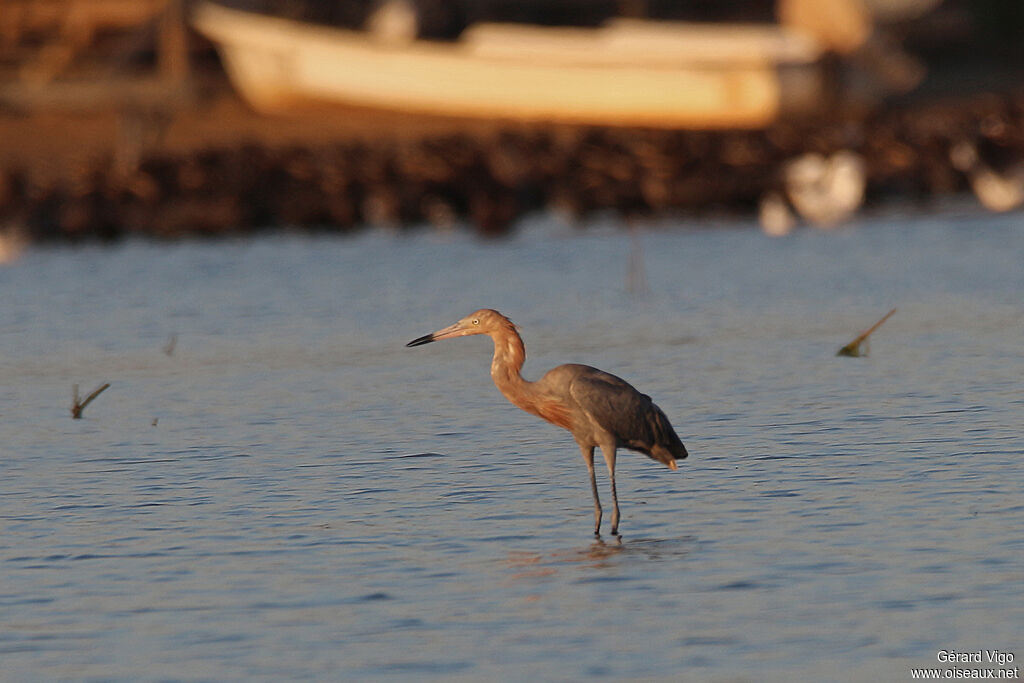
[505,536,697,579]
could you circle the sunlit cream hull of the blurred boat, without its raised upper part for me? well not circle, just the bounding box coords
[195,4,820,128]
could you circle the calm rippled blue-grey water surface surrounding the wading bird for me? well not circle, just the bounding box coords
[0,215,1024,681]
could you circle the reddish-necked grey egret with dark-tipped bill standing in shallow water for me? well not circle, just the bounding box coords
[406,308,687,536]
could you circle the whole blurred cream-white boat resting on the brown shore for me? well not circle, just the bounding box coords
[193,3,823,129]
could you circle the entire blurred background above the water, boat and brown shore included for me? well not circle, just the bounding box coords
[0,0,1024,249]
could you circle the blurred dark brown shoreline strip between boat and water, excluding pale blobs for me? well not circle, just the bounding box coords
[0,87,1024,242]
